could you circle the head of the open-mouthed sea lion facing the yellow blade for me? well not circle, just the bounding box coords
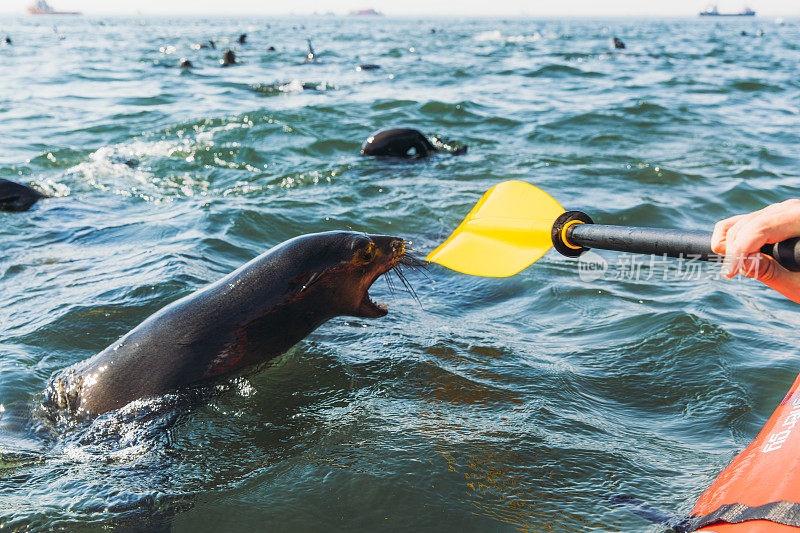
[282,231,422,318]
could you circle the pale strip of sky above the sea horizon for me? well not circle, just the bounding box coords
[0,0,800,17]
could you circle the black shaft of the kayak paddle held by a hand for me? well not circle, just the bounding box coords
[553,211,800,272]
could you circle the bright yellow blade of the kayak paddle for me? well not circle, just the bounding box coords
[425,181,564,278]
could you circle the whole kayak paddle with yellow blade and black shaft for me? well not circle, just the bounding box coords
[425,181,800,278]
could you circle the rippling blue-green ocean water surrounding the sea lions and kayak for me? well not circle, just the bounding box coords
[0,16,800,532]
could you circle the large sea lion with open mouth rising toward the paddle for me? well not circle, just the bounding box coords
[41,231,410,418]
